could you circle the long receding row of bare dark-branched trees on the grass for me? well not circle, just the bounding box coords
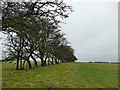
[1,0,77,70]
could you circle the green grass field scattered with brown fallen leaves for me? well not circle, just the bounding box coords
[2,62,118,88]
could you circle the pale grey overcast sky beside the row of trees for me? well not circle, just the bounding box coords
[0,0,118,61]
